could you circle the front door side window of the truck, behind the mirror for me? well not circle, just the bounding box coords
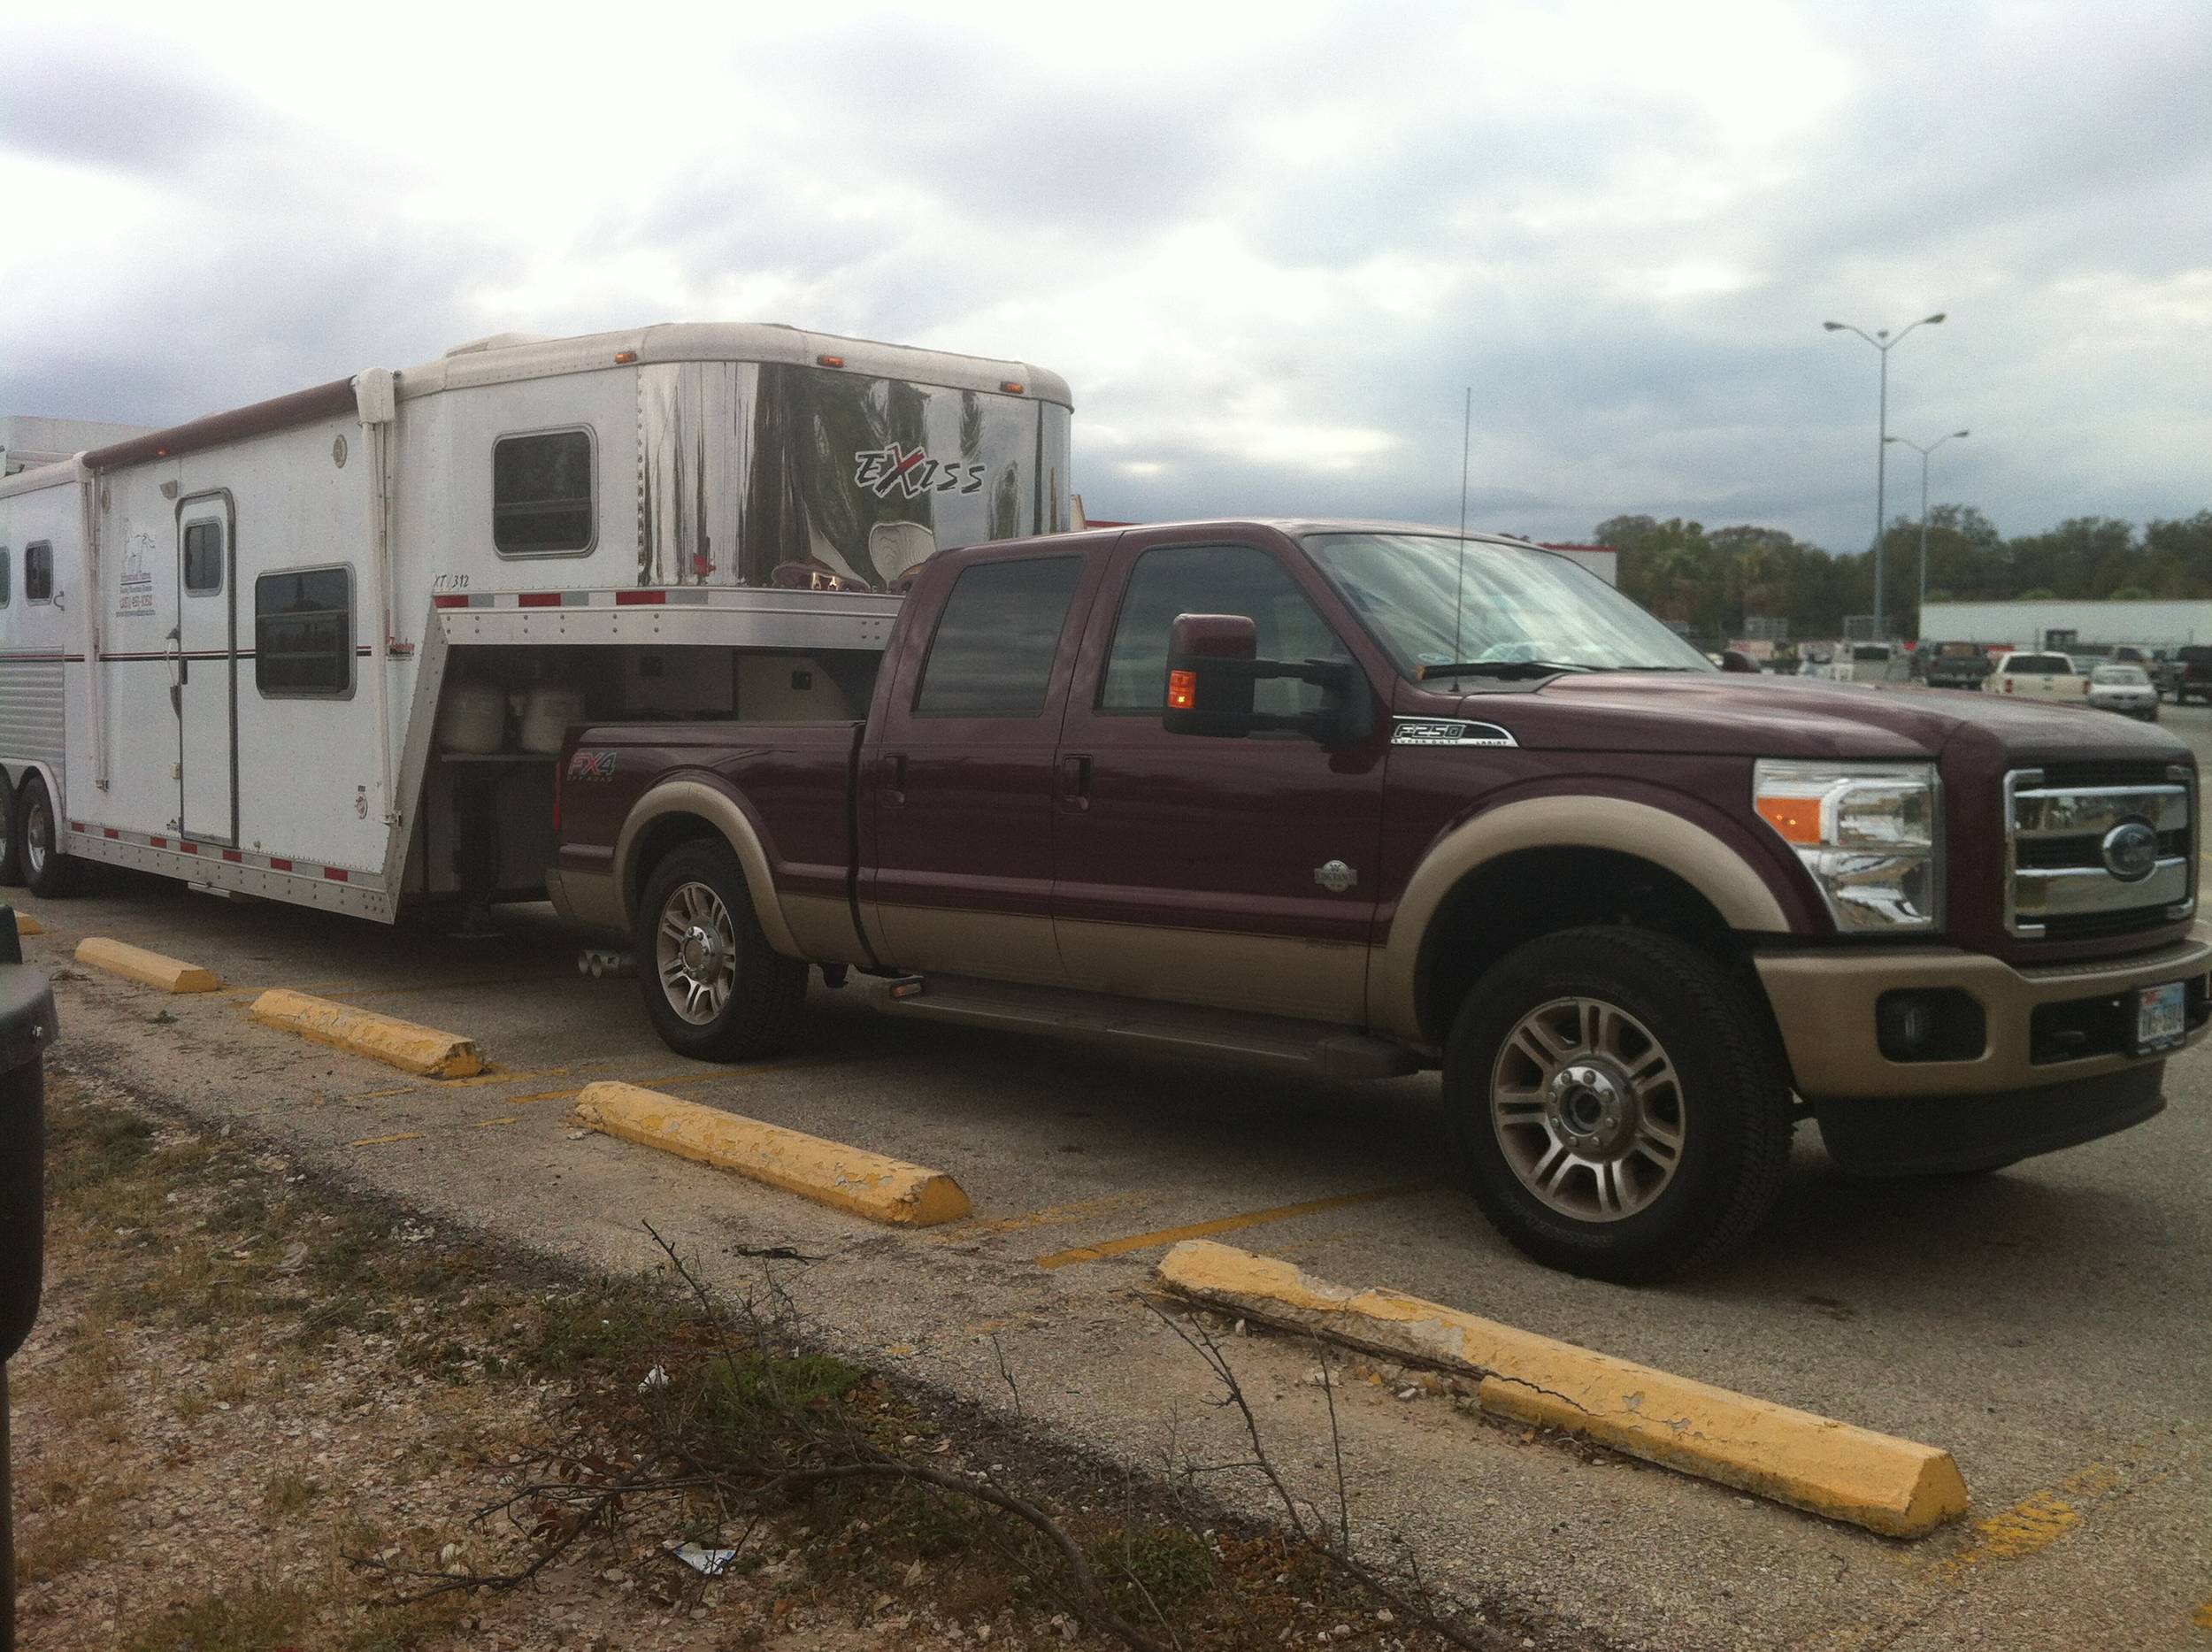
[1100,544,1349,717]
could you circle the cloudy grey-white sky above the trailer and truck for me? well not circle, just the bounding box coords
[0,0,2212,549]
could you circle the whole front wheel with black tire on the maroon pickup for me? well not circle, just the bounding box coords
[1445,929,1794,1285]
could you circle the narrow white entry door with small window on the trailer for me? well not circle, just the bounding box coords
[173,493,239,845]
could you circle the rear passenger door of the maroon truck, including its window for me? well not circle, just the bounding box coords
[861,546,1102,982]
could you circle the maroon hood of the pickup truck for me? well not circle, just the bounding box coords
[1398,672,2190,763]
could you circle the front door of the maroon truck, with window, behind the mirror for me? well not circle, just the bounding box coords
[1053,533,1389,1026]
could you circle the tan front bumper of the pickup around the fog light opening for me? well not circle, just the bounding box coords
[1755,940,2212,1099]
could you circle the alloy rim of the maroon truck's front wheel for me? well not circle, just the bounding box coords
[1491,997,1686,1221]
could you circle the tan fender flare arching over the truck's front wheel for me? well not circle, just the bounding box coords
[1367,794,1790,1037]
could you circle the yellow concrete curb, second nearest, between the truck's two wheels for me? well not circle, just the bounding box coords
[571,1084,973,1227]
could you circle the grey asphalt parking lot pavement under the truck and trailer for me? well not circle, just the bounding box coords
[22,708,2212,1652]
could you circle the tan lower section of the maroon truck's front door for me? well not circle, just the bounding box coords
[1060,920,1370,1026]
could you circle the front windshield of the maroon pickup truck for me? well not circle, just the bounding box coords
[1305,533,1715,679]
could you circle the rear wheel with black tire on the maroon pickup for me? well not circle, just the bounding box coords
[637,838,808,1062]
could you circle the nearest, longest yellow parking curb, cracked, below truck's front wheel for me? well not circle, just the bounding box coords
[1159,1239,1967,1537]
